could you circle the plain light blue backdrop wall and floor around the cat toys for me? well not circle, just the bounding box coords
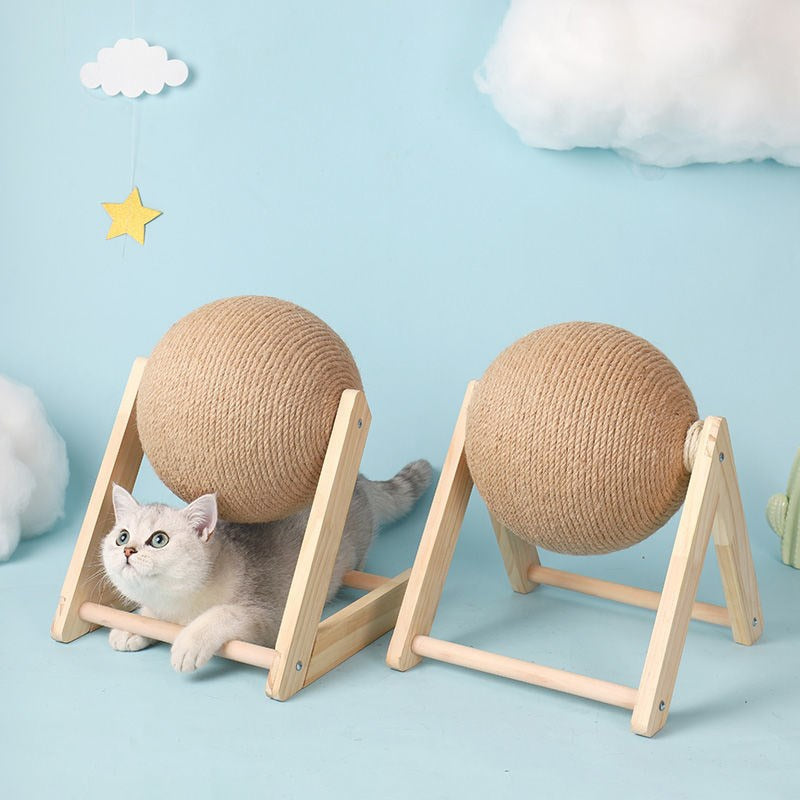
[0,0,800,797]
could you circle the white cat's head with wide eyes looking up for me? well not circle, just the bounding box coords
[101,485,217,605]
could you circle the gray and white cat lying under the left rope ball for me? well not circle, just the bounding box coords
[102,460,431,672]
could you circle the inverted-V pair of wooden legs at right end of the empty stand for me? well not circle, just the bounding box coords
[631,417,761,736]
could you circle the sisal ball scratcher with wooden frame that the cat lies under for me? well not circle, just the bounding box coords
[52,296,408,700]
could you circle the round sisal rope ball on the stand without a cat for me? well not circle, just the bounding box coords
[466,322,697,555]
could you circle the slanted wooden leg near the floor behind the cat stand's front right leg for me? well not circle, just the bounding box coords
[304,569,411,686]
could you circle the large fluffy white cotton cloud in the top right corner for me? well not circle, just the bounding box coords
[476,0,800,167]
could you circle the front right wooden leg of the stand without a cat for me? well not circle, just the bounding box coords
[631,417,722,736]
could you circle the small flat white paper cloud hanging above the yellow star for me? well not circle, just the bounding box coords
[81,39,189,97]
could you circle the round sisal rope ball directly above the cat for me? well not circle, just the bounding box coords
[136,297,361,522]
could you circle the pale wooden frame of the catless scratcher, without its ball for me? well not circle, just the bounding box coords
[386,383,763,736]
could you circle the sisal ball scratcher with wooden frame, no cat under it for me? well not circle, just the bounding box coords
[387,322,763,736]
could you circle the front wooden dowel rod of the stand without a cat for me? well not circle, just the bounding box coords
[411,636,636,710]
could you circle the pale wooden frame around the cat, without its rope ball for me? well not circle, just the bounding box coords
[51,358,409,700]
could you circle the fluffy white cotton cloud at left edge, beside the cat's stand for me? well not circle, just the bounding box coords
[0,375,69,561]
